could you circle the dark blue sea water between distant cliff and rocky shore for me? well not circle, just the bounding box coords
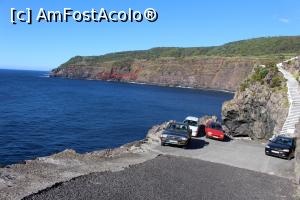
[0,70,233,165]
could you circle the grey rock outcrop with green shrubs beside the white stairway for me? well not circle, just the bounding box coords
[222,65,289,140]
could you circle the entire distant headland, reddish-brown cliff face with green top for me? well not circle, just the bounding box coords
[50,36,300,91]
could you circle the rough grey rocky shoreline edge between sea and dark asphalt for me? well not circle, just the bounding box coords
[0,123,166,200]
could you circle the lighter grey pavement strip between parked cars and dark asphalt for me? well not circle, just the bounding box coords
[152,137,295,179]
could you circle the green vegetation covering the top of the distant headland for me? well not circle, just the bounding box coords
[61,36,300,67]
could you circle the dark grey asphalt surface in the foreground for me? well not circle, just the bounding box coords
[24,156,295,200]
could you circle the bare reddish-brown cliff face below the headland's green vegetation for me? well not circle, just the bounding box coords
[51,56,265,91]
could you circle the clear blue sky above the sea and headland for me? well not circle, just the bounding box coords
[0,0,300,70]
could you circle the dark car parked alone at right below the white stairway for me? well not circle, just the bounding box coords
[265,135,296,160]
